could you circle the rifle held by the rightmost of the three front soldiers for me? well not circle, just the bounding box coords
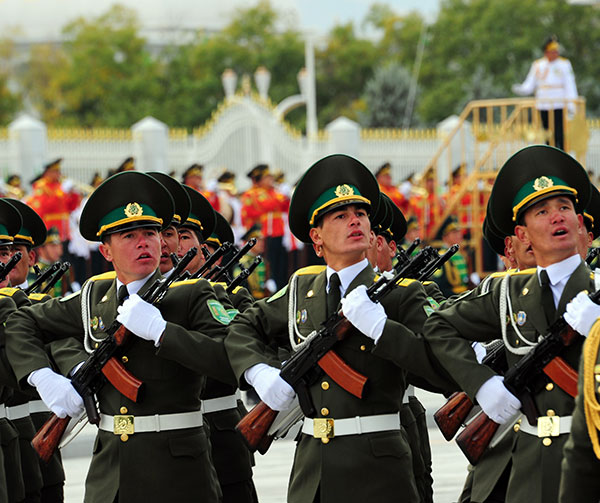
[456,290,600,465]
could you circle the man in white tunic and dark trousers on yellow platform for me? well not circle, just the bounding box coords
[512,35,577,149]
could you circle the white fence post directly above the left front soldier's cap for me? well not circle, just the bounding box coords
[131,117,169,173]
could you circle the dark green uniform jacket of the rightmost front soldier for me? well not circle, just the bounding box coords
[425,262,594,503]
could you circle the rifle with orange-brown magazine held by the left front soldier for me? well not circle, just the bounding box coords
[31,248,198,462]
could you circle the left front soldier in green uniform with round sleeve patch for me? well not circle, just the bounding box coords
[6,171,233,502]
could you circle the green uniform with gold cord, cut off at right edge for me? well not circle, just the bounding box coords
[559,341,600,503]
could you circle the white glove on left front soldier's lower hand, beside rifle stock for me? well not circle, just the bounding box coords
[27,367,83,418]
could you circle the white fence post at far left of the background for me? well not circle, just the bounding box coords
[8,115,48,186]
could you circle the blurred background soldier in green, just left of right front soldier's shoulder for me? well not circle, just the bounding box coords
[433,216,469,298]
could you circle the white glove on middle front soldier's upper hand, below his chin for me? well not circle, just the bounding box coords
[342,285,387,343]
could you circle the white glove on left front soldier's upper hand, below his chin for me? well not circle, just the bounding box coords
[117,293,167,347]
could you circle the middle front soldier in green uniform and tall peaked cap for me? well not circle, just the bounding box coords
[225,155,454,503]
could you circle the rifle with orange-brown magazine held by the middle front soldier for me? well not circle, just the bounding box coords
[236,249,439,454]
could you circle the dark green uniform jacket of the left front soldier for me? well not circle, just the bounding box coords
[7,272,234,503]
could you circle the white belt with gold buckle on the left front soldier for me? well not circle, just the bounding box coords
[98,410,202,435]
